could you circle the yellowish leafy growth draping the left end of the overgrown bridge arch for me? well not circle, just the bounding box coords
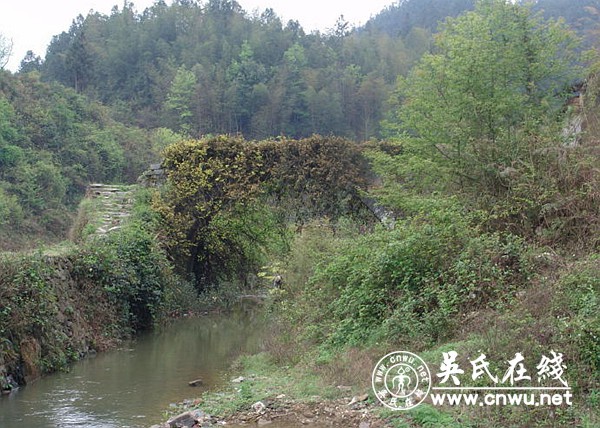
[155,137,264,288]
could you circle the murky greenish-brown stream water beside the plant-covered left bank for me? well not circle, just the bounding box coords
[0,306,263,428]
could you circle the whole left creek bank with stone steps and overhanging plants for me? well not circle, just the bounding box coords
[0,184,197,391]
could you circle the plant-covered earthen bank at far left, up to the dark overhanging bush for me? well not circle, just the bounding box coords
[0,253,128,391]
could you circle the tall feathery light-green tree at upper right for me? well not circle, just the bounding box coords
[397,0,578,192]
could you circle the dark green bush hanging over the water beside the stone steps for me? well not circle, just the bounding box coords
[74,187,193,332]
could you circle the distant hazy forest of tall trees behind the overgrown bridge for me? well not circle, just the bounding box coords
[36,0,429,140]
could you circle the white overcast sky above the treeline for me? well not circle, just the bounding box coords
[0,0,396,71]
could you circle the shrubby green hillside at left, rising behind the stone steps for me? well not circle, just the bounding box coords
[0,71,164,249]
